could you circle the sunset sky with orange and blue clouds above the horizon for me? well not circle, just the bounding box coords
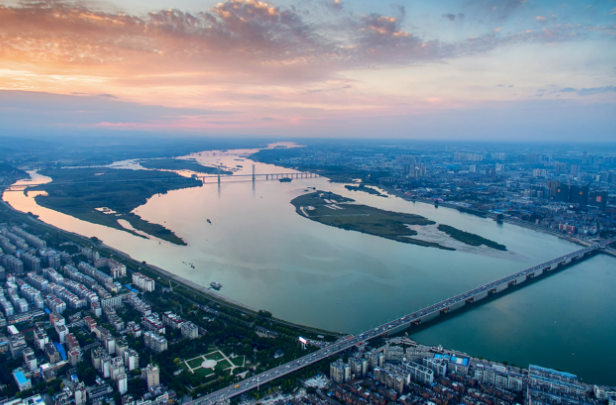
[0,0,616,141]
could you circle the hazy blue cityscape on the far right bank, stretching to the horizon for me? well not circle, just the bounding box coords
[257,144,616,239]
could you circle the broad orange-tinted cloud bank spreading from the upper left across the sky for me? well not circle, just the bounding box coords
[0,0,613,97]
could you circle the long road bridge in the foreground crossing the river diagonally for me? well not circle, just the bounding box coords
[190,238,616,405]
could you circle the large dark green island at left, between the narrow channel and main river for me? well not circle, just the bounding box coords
[28,168,202,245]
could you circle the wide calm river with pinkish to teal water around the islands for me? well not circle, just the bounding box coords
[3,151,616,385]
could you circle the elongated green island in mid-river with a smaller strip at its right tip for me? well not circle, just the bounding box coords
[291,191,507,250]
